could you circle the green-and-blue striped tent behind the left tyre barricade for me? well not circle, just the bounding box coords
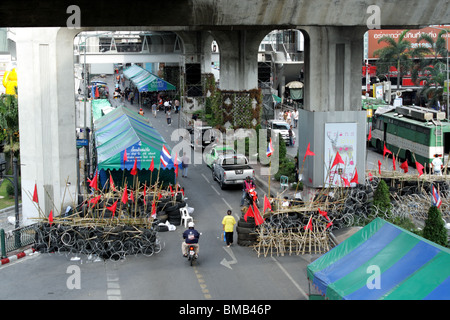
[94,107,178,185]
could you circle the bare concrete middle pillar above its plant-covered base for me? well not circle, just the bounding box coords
[211,30,270,91]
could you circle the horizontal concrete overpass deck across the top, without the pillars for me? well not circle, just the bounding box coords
[0,0,450,27]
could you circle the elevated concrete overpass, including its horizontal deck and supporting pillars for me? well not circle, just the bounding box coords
[0,0,450,224]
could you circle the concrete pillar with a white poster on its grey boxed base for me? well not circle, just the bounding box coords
[298,27,366,188]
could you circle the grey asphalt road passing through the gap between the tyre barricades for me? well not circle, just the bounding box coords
[0,87,318,301]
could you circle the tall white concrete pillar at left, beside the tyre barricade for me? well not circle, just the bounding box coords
[16,28,77,225]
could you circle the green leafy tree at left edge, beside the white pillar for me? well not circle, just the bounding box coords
[0,94,20,167]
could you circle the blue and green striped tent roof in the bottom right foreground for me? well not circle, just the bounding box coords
[307,218,450,300]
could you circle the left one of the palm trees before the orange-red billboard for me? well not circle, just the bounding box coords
[374,30,411,89]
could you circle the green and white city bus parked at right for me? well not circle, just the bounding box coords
[370,106,450,168]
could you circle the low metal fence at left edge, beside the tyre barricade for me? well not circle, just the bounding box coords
[0,225,36,259]
